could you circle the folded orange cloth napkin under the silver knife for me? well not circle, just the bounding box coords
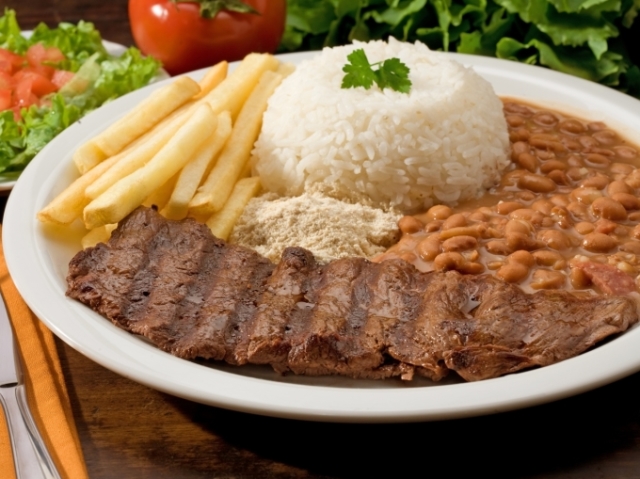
[0,226,88,479]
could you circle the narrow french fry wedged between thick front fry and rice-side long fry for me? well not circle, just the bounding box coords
[162,111,231,220]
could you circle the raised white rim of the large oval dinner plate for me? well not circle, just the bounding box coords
[2,48,640,422]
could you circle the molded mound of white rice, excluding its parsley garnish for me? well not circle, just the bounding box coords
[252,35,509,212]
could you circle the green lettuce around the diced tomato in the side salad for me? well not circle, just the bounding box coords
[0,9,160,181]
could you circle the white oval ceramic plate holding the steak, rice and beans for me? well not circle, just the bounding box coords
[3,53,640,422]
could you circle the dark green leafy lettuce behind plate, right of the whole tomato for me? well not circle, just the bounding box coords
[280,0,640,98]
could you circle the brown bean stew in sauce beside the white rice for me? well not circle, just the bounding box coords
[375,100,640,295]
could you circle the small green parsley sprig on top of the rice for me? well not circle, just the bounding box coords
[341,48,411,93]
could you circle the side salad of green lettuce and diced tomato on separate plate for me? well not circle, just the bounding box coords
[0,9,161,182]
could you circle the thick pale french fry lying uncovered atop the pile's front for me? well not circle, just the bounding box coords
[83,104,217,229]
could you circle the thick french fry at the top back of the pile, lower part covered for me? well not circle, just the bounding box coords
[203,53,280,120]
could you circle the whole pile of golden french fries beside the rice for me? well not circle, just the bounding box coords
[38,54,294,247]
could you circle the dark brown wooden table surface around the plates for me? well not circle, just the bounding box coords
[2,0,640,479]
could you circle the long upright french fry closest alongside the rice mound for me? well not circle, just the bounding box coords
[189,71,282,216]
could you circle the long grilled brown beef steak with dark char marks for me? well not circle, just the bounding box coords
[67,207,638,380]
